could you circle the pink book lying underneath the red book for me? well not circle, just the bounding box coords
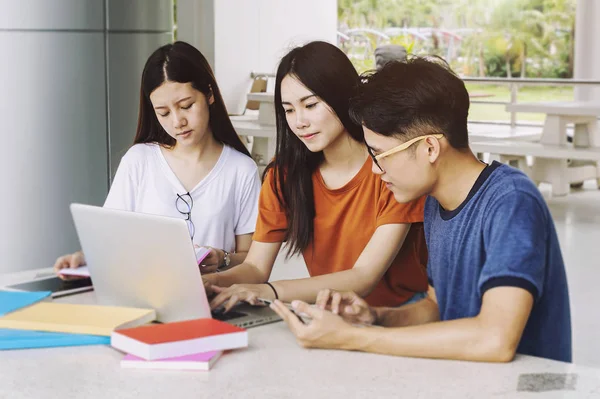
[121,351,223,371]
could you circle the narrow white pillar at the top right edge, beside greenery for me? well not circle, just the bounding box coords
[574,0,600,101]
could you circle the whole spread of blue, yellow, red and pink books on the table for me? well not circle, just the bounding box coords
[0,291,248,370]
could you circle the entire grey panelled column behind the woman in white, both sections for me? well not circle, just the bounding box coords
[0,0,172,273]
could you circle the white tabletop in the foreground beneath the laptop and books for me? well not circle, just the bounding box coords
[0,272,600,399]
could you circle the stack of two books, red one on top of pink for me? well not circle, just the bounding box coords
[111,319,248,370]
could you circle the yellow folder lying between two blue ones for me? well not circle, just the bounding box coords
[0,302,156,336]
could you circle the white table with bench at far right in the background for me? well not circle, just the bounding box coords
[506,101,600,195]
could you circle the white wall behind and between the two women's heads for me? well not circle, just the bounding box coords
[177,0,337,113]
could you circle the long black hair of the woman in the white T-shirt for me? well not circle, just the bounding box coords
[133,42,250,156]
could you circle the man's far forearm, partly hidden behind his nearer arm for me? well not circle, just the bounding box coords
[374,298,440,327]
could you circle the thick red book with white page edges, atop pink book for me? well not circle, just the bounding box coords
[110,319,248,360]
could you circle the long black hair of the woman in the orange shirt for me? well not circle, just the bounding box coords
[264,41,364,256]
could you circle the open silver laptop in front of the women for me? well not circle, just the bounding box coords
[71,204,281,328]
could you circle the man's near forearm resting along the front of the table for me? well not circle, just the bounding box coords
[340,318,516,362]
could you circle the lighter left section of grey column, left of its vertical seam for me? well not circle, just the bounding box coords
[0,0,108,273]
